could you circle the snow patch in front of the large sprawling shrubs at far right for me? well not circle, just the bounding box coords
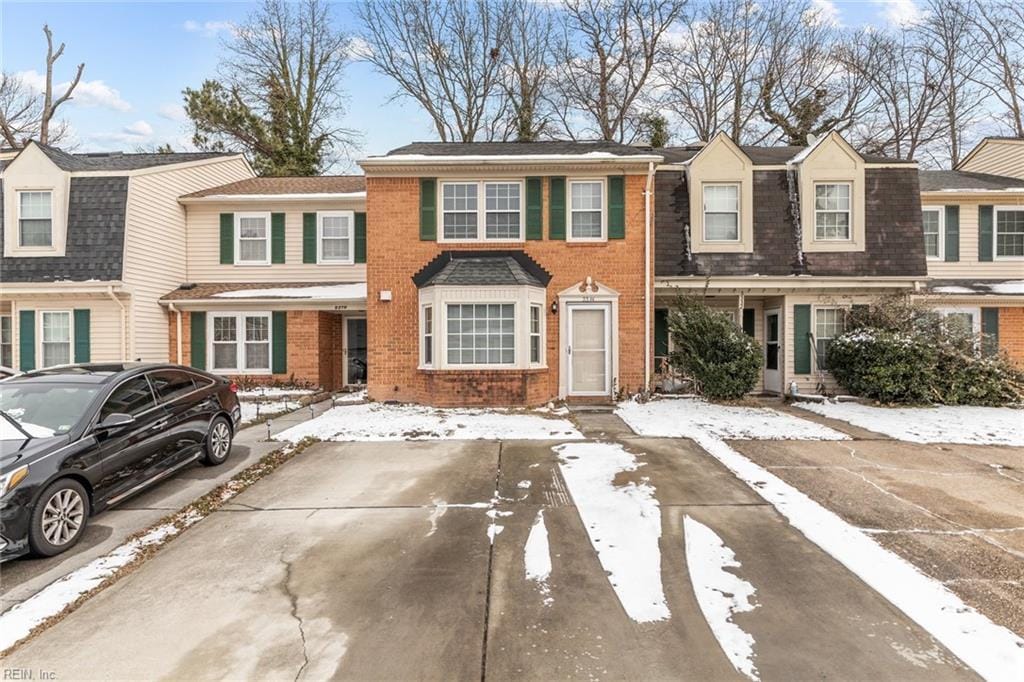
[796,402,1024,445]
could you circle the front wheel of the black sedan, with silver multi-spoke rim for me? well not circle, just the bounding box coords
[29,478,89,556]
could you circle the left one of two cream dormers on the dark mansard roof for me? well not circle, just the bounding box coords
[687,132,754,253]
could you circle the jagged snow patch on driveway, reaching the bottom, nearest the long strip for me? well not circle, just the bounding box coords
[683,516,760,680]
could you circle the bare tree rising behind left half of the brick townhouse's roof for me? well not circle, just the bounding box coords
[357,0,510,142]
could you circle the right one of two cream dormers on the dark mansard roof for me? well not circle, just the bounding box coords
[790,131,865,253]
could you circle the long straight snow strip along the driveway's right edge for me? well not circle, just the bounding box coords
[696,436,1024,682]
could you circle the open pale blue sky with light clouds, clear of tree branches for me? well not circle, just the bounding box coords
[0,0,914,164]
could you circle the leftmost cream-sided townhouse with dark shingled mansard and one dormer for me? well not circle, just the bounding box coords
[0,142,253,371]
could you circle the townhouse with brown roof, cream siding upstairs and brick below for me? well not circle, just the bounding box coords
[160,176,367,390]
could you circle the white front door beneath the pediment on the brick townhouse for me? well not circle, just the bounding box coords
[566,303,611,395]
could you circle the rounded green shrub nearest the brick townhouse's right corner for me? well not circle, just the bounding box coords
[669,297,762,400]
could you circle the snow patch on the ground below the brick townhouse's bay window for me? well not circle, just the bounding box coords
[274,402,583,442]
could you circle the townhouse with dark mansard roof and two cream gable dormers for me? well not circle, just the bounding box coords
[653,133,928,393]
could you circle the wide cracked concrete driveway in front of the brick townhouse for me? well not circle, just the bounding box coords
[3,438,975,680]
